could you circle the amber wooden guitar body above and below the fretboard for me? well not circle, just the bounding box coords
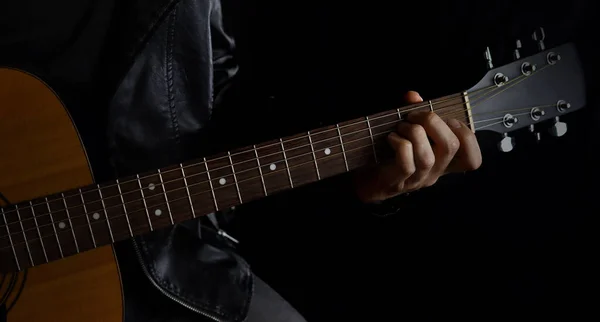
[0,69,123,322]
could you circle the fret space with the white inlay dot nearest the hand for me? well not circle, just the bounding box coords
[311,125,348,178]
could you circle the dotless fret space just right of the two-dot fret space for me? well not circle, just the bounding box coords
[160,164,194,222]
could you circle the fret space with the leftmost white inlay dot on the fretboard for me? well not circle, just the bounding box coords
[48,195,79,256]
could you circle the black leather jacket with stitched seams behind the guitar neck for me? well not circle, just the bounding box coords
[103,0,400,321]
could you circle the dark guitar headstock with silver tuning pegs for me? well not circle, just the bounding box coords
[467,41,586,152]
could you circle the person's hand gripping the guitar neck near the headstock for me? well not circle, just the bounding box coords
[354,91,481,202]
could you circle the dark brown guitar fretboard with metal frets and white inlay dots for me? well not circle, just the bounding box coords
[0,93,469,270]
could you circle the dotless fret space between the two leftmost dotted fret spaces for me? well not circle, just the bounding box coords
[61,189,94,252]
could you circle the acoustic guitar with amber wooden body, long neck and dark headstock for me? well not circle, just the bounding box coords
[0,44,585,322]
